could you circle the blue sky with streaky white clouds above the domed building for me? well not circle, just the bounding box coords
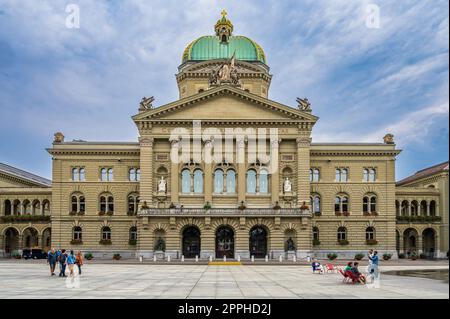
[0,0,449,179]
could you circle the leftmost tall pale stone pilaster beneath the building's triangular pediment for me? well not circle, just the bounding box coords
[139,137,154,207]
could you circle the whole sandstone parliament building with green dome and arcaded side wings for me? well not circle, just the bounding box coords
[0,12,449,260]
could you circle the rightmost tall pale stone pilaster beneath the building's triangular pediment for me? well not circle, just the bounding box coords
[297,131,311,206]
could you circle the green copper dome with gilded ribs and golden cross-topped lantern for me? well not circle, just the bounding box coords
[181,11,266,64]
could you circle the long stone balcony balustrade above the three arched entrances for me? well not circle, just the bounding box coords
[138,208,311,217]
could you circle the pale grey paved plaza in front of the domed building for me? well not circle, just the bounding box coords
[0,261,449,299]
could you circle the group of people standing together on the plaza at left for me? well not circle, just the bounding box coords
[47,248,83,277]
